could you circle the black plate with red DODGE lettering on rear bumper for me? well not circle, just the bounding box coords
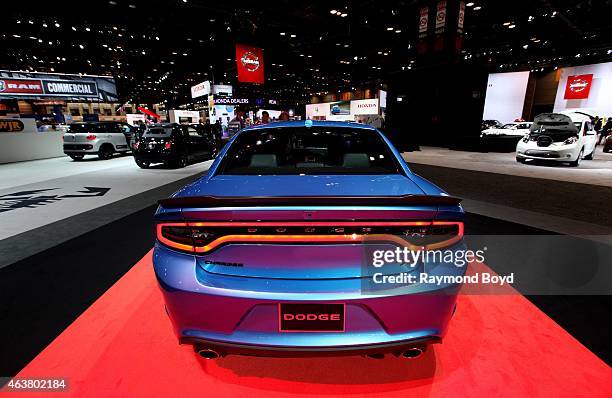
[278,303,345,332]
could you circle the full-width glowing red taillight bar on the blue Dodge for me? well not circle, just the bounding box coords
[157,221,463,253]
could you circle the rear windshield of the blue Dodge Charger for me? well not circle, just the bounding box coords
[219,127,400,174]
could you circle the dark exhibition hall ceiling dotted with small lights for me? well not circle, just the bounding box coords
[0,0,612,104]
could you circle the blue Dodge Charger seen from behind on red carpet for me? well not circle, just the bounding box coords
[153,120,465,359]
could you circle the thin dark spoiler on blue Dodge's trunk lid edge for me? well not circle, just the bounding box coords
[159,195,461,209]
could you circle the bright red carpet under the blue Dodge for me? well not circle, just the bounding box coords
[1,253,612,398]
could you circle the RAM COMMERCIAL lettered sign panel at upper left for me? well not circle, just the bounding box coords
[0,78,98,97]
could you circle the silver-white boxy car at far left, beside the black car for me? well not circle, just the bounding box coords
[64,122,132,160]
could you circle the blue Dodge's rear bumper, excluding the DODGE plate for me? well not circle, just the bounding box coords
[154,244,464,356]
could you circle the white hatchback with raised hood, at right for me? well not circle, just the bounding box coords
[516,112,597,166]
